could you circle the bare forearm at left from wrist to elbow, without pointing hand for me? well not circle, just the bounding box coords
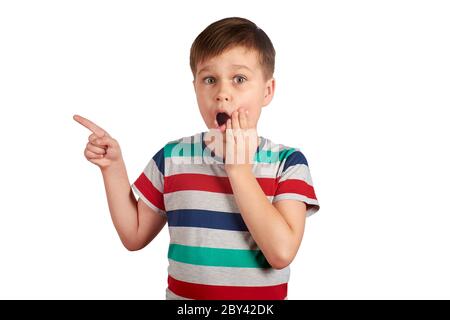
[102,161,166,251]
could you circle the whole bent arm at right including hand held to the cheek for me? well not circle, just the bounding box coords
[225,109,306,269]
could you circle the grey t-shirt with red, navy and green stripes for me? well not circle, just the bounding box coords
[132,132,319,300]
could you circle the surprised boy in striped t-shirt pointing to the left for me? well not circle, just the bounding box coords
[74,18,319,299]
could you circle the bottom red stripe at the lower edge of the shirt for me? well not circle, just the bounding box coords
[168,276,287,300]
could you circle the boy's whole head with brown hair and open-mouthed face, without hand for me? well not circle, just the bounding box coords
[190,18,275,130]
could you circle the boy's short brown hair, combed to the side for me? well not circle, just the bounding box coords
[190,17,275,80]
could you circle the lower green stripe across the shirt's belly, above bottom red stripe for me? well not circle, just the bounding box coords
[168,244,270,268]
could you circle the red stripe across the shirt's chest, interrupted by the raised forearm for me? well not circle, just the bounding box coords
[164,173,276,196]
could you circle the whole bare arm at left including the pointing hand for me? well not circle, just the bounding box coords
[74,115,166,250]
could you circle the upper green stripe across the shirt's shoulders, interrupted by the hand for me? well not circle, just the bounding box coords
[164,142,295,163]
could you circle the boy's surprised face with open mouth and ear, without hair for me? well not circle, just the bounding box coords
[193,47,275,132]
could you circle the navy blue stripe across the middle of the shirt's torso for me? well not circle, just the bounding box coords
[167,209,248,231]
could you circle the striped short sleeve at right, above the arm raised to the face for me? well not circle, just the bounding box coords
[273,149,320,217]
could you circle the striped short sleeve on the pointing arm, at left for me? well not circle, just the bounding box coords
[131,148,166,215]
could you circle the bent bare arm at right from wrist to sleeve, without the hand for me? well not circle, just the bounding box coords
[228,165,306,269]
